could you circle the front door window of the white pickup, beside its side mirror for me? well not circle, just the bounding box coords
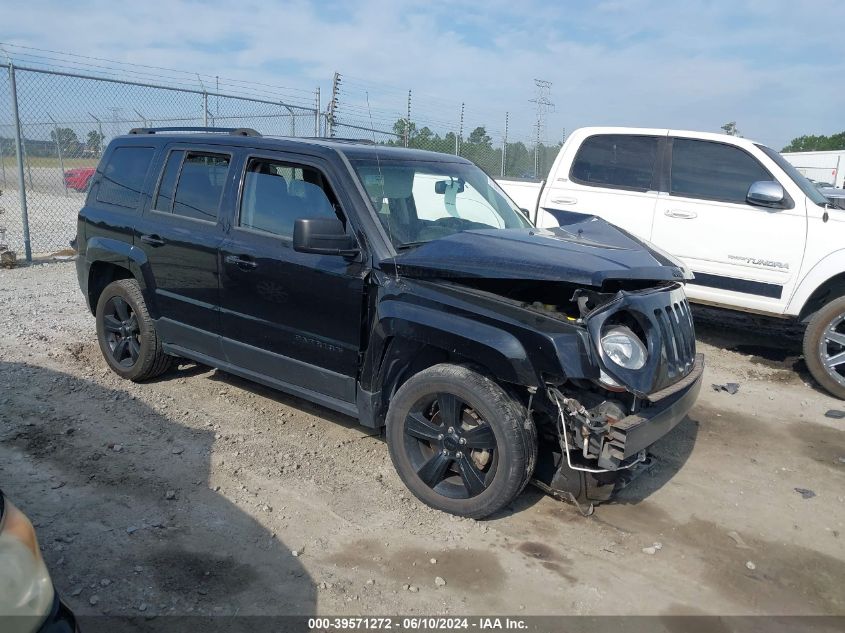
[669,138,772,204]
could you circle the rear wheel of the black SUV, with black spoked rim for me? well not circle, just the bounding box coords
[96,279,173,381]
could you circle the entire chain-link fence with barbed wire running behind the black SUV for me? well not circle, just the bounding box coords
[0,63,562,259]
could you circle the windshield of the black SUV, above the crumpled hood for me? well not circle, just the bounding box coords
[352,159,531,250]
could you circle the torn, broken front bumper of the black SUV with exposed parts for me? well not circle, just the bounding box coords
[534,354,704,503]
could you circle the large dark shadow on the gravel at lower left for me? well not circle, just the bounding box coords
[0,362,316,631]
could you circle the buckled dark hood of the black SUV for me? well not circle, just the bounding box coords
[381,214,692,287]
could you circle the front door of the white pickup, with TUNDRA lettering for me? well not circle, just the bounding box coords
[652,137,807,312]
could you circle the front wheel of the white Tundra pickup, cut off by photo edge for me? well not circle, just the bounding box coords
[804,297,845,400]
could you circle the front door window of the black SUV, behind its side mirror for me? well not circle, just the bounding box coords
[238,158,342,238]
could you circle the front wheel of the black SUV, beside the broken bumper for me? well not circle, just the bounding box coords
[387,364,537,519]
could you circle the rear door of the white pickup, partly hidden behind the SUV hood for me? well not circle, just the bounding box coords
[541,133,664,239]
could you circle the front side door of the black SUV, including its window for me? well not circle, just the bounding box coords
[220,152,366,403]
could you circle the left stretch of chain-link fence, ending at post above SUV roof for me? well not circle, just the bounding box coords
[0,65,320,257]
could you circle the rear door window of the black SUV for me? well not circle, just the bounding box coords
[173,152,230,222]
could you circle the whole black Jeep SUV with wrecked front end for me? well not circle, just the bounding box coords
[77,129,703,518]
